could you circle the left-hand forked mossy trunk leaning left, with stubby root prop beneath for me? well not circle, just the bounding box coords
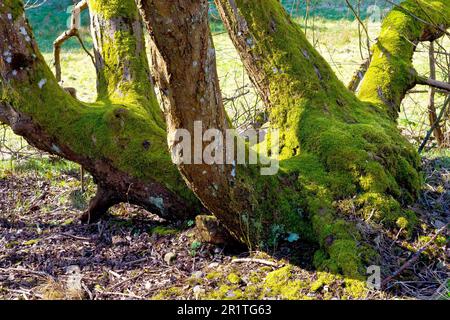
[0,0,199,221]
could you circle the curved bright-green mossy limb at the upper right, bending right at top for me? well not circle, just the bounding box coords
[359,0,450,119]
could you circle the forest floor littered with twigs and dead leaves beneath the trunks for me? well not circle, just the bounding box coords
[0,158,450,299]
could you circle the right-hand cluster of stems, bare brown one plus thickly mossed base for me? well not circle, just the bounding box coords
[139,0,450,277]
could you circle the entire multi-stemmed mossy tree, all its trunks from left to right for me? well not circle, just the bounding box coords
[0,0,450,278]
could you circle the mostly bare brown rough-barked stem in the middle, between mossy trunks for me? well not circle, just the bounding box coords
[138,0,266,245]
